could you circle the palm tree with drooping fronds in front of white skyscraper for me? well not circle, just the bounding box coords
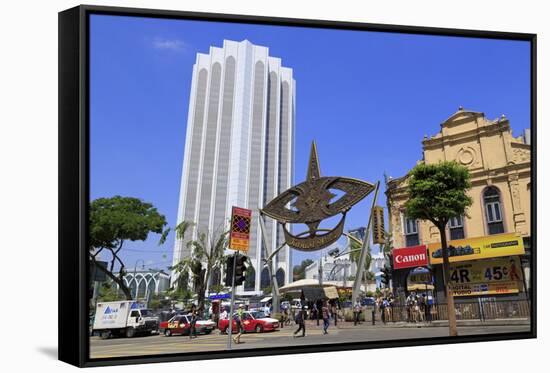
[170,222,229,311]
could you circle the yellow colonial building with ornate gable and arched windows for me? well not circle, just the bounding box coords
[386,108,531,302]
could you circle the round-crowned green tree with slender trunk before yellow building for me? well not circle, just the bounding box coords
[405,161,472,336]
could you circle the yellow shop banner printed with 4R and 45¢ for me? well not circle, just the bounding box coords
[450,256,523,297]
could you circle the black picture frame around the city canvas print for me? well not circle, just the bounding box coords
[58,5,537,367]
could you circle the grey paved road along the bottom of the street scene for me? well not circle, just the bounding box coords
[90,322,529,358]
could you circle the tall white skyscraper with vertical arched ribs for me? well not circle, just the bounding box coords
[173,40,296,293]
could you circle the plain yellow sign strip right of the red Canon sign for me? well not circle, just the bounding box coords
[428,233,525,264]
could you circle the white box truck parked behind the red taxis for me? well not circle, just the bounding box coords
[93,300,159,339]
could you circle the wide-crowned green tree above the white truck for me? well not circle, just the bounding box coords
[89,196,167,300]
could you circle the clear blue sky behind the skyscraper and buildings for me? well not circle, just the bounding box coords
[90,15,530,269]
